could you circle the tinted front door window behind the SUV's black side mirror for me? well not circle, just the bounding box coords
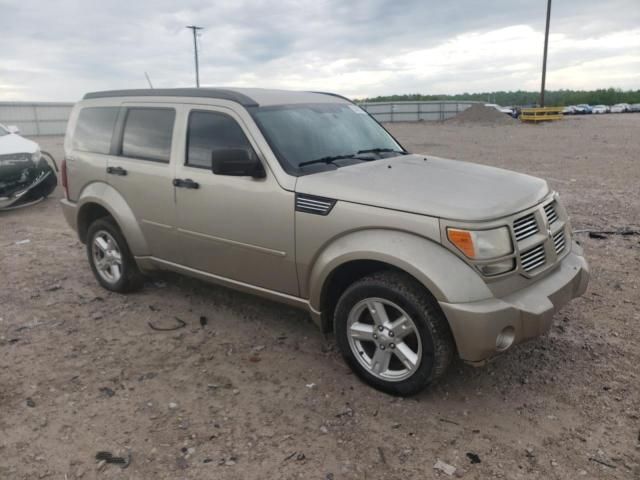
[186,112,251,168]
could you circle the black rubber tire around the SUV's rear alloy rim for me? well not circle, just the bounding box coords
[87,217,144,293]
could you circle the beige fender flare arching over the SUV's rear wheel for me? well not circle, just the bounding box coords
[77,182,151,257]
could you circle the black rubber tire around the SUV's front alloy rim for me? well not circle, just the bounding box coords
[334,271,455,396]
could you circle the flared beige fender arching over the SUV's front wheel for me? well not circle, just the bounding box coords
[309,229,492,312]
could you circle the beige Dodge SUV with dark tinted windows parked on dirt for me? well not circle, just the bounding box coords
[62,88,589,395]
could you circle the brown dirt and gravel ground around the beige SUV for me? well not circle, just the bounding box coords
[0,115,640,480]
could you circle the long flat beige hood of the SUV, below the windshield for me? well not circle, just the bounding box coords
[296,155,549,221]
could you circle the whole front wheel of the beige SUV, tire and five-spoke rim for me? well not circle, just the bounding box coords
[335,272,455,395]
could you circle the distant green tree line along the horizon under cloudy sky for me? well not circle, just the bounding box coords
[356,88,640,106]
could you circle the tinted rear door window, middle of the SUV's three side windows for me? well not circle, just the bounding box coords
[122,108,176,163]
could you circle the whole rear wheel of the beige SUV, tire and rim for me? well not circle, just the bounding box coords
[87,217,143,293]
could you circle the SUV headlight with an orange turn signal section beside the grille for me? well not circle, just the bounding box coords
[447,227,513,260]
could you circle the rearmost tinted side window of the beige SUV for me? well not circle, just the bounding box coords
[73,107,120,153]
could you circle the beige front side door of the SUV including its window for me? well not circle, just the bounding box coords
[174,106,298,295]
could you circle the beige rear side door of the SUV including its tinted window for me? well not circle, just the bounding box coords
[106,103,181,263]
